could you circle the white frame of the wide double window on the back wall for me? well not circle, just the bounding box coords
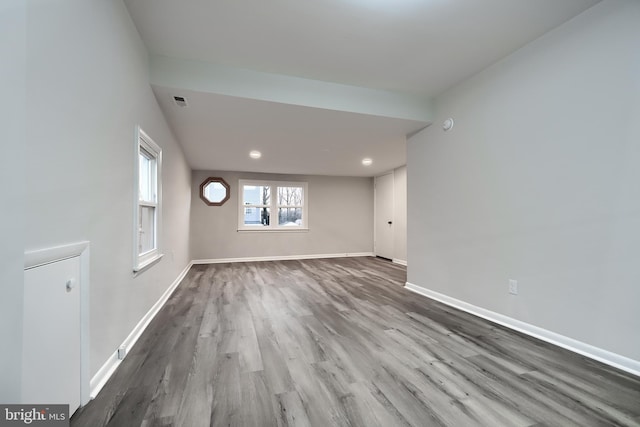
[238,179,309,233]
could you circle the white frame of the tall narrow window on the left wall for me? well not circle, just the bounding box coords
[133,126,162,272]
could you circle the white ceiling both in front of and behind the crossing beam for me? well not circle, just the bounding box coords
[125,0,598,176]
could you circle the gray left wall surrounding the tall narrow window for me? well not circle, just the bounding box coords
[23,0,191,382]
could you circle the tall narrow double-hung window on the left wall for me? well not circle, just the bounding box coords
[133,127,162,271]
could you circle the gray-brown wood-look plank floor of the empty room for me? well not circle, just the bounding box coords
[71,258,640,427]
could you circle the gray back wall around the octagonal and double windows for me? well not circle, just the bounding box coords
[191,171,373,259]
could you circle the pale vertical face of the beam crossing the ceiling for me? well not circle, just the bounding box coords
[149,55,435,125]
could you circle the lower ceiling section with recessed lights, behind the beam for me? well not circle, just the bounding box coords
[154,87,424,176]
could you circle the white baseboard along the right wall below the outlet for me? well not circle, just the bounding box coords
[405,282,640,376]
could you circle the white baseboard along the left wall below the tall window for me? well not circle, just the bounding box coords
[89,263,193,399]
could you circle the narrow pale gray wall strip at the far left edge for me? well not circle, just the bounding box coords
[0,0,27,403]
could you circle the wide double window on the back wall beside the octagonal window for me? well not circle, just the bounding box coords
[238,180,308,231]
